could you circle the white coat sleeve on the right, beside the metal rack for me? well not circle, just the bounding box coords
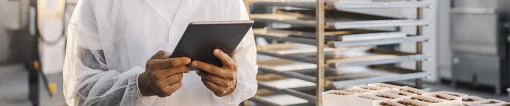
[215,2,258,105]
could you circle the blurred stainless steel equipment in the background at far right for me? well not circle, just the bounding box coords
[451,0,510,94]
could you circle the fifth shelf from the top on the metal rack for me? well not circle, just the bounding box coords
[259,66,430,89]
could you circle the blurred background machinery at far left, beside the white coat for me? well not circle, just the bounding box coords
[0,0,72,106]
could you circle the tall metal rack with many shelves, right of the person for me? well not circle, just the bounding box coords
[251,0,430,106]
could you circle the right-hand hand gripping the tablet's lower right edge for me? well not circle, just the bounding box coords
[191,49,237,97]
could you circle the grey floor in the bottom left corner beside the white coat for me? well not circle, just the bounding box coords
[0,64,66,106]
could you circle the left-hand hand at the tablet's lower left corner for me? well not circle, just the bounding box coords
[138,51,191,97]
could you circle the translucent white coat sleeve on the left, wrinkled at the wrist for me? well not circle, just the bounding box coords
[63,0,155,106]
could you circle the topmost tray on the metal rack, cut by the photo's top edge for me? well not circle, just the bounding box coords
[252,0,431,10]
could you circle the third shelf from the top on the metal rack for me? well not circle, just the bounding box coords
[254,29,428,47]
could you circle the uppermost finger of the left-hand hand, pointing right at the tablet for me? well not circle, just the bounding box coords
[150,57,191,69]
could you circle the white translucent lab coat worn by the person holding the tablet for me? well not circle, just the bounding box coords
[64,0,257,106]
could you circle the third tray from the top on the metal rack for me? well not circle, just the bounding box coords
[253,28,428,47]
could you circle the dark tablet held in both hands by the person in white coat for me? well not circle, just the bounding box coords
[170,21,253,67]
